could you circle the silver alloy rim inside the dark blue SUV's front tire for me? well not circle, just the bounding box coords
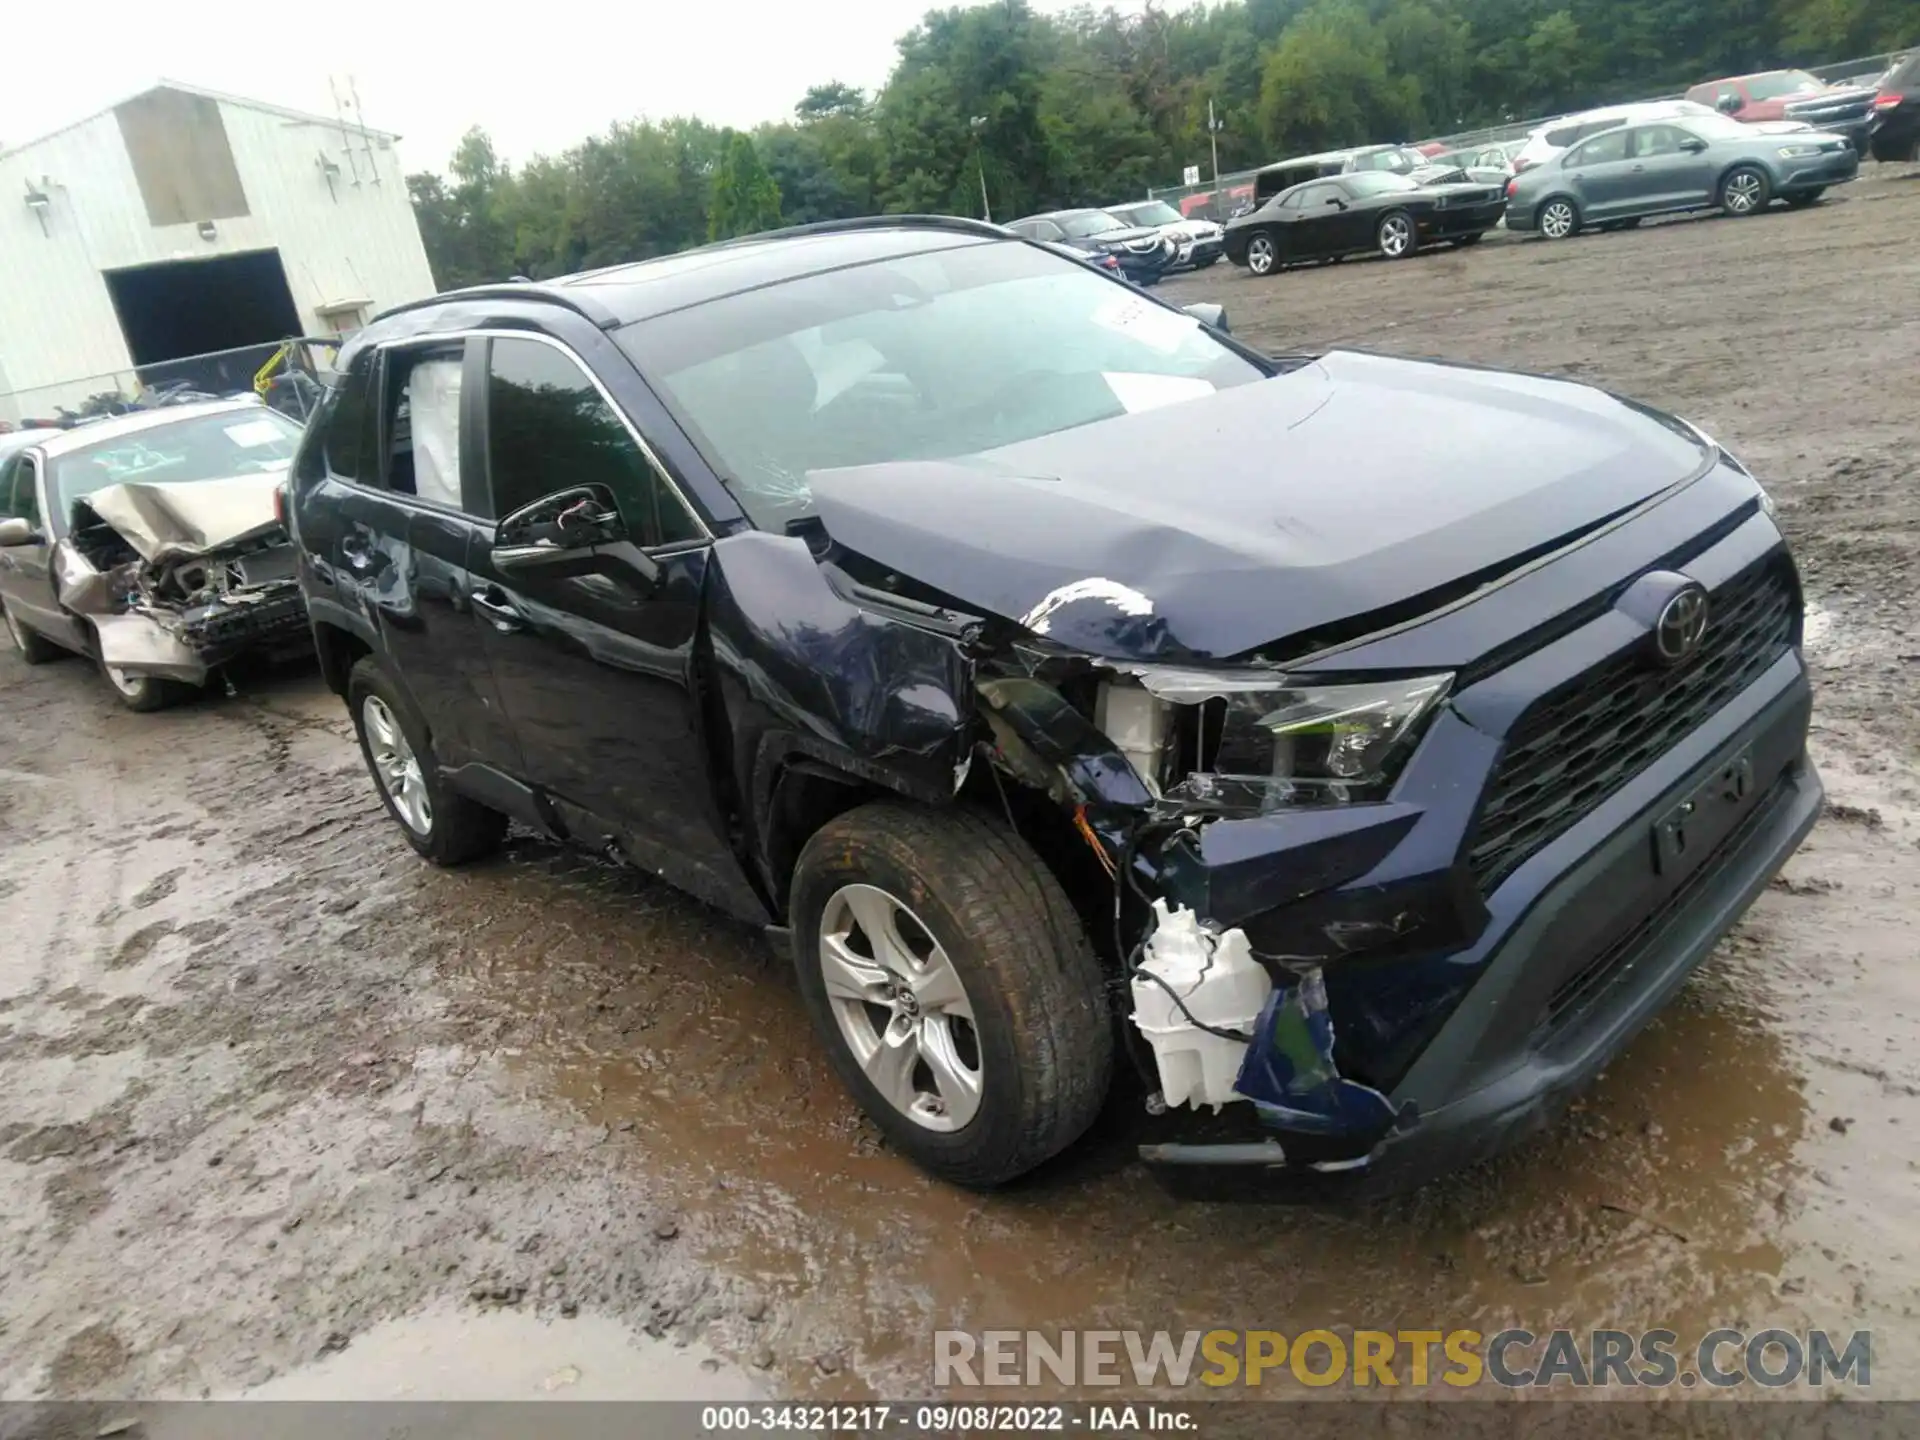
[818,885,985,1133]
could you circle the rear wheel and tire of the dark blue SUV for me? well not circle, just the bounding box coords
[348,655,507,866]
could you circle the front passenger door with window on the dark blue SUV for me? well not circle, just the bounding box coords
[468,336,766,922]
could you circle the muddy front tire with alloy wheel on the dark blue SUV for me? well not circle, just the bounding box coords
[789,801,1114,1188]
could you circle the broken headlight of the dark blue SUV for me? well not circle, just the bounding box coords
[1140,670,1453,814]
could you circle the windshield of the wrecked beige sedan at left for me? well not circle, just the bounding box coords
[52,407,300,515]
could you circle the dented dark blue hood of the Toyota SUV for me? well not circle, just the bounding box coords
[808,351,1711,659]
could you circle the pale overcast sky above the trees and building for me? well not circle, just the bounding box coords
[0,0,1142,171]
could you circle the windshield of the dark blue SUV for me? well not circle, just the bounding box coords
[618,244,1265,530]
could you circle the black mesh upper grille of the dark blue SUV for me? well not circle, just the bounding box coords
[1467,559,1799,893]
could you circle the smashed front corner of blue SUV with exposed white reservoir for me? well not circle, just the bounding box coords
[977,629,1459,1171]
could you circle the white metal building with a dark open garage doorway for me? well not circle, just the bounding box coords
[0,81,434,420]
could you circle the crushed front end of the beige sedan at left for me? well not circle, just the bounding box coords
[52,474,307,685]
